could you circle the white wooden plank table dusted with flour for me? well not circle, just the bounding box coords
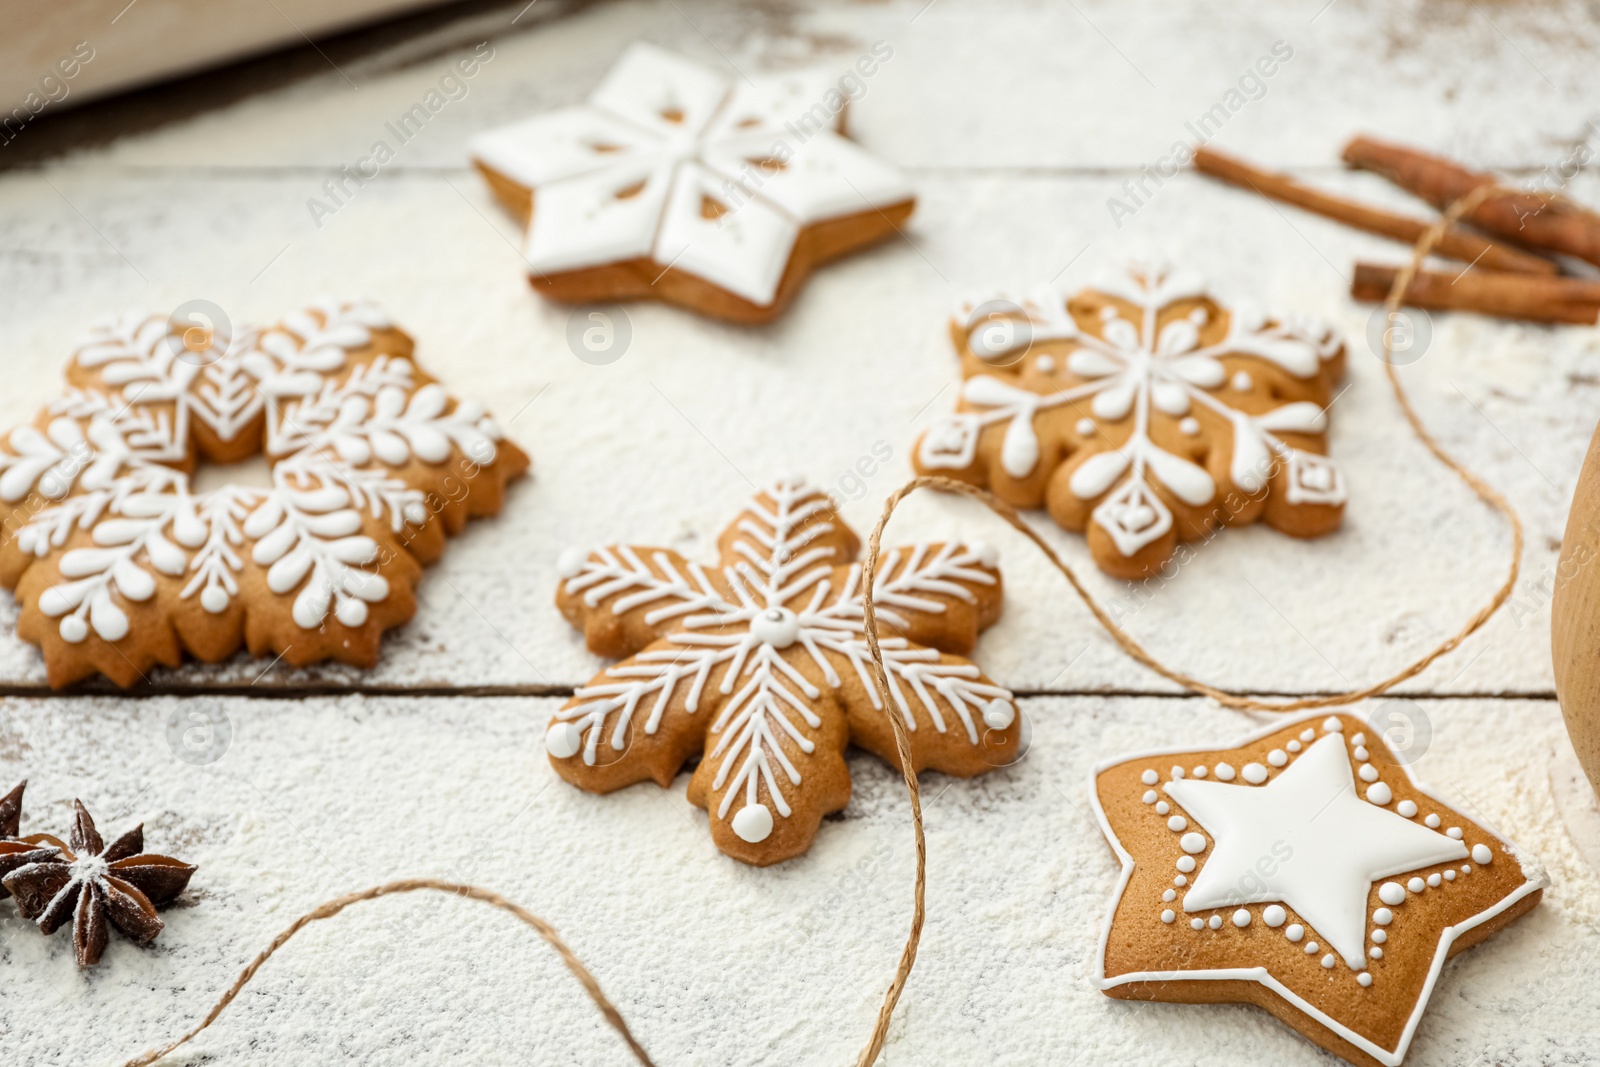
[0,0,1600,1064]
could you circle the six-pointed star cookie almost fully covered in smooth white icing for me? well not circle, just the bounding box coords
[470,43,915,323]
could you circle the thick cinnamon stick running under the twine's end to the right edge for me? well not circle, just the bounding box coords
[1344,138,1600,266]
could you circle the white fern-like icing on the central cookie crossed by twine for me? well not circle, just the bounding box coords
[546,480,1016,843]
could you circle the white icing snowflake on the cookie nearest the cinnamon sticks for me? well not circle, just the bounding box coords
[918,267,1344,555]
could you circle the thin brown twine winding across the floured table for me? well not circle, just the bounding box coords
[123,184,1523,1067]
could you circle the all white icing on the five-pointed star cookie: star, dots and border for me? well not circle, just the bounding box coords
[1090,717,1549,1067]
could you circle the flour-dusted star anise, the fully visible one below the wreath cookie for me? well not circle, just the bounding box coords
[3,800,195,966]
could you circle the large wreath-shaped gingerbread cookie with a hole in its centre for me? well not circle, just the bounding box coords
[0,295,528,686]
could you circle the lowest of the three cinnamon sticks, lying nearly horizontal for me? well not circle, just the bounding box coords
[1350,262,1600,326]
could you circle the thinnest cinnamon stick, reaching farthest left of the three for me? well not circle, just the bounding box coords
[1194,146,1557,274]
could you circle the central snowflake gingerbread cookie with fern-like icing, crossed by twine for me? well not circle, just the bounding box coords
[546,480,1022,865]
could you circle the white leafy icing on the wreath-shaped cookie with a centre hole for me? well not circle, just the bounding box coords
[0,301,501,643]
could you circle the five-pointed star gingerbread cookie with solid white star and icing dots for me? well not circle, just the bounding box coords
[1091,713,1546,1067]
